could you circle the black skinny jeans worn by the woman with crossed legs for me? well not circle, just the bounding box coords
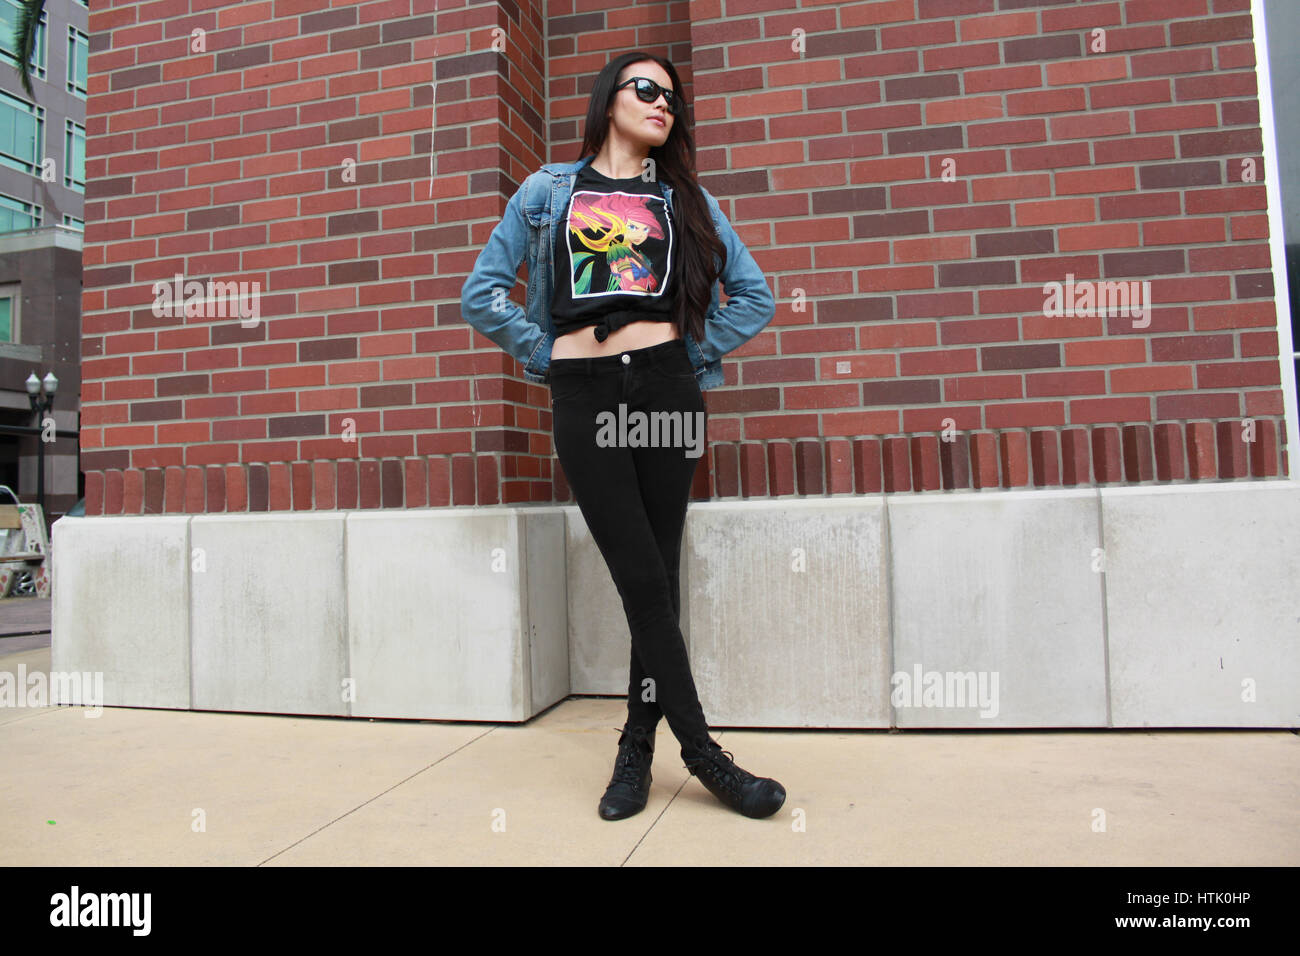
[550,338,709,758]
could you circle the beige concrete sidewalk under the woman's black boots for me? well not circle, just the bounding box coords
[0,624,1300,866]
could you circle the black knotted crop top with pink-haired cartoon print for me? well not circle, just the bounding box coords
[551,163,680,342]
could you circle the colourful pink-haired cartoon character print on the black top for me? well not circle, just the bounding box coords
[569,191,668,297]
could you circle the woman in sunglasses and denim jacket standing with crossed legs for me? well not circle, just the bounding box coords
[462,51,785,819]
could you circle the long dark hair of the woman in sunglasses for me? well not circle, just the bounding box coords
[579,49,727,342]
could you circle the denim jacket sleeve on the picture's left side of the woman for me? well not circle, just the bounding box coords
[460,179,546,364]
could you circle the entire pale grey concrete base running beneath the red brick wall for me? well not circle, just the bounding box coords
[51,481,1300,732]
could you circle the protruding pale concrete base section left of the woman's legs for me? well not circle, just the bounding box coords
[51,507,569,721]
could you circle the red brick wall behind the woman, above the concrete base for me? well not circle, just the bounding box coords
[82,0,1286,514]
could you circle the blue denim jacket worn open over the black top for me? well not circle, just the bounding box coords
[460,155,776,390]
